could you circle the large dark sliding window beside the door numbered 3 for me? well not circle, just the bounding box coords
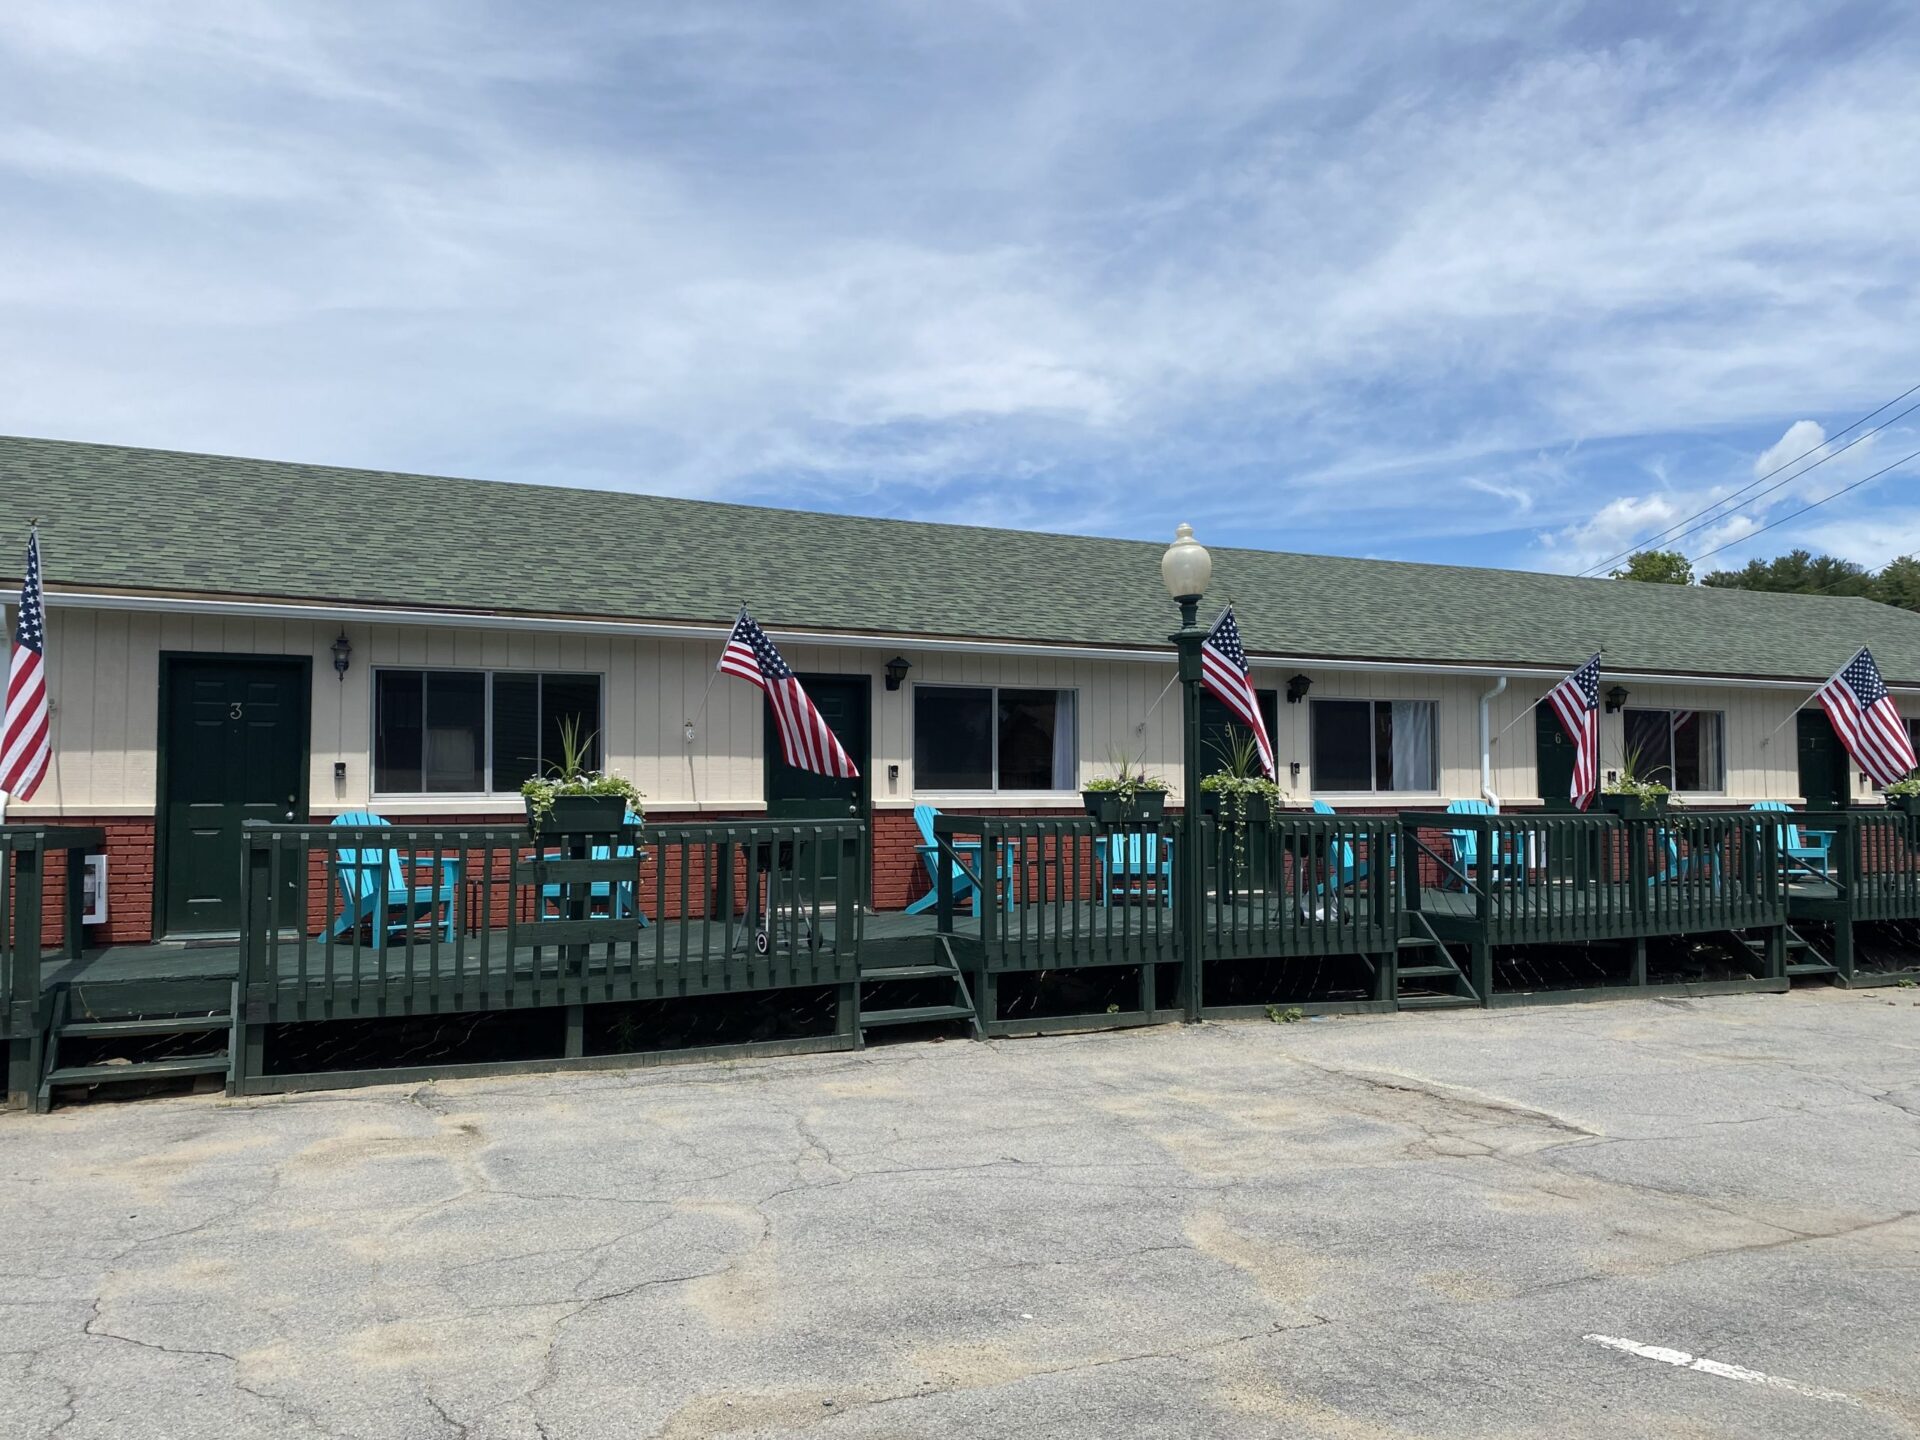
[372,670,601,795]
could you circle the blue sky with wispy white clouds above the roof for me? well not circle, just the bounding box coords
[0,0,1920,570]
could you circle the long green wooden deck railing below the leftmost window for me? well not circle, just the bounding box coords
[238,820,866,1025]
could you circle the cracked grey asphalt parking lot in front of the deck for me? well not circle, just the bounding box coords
[0,991,1920,1440]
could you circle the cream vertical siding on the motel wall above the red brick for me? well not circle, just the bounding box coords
[17,601,1920,816]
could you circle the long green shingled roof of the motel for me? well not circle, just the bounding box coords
[0,438,1920,682]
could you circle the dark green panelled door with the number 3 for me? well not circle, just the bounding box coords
[159,655,309,935]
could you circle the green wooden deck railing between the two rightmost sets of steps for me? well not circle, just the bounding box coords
[1400,810,1786,945]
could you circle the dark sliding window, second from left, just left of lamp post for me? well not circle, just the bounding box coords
[914,685,1079,791]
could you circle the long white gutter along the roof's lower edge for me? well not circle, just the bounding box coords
[18,589,1920,695]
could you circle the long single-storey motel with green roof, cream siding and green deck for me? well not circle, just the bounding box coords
[0,440,1920,1102]
